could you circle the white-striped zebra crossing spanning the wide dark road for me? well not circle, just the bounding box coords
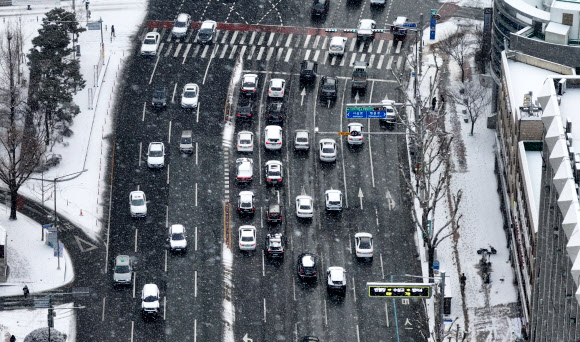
[142,28,404,70]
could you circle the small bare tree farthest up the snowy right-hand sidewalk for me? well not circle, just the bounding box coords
[433,27,474,83]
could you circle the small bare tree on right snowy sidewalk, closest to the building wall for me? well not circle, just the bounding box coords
[451,77,491,135]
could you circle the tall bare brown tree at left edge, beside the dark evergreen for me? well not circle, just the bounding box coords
[0,25,44,220]
